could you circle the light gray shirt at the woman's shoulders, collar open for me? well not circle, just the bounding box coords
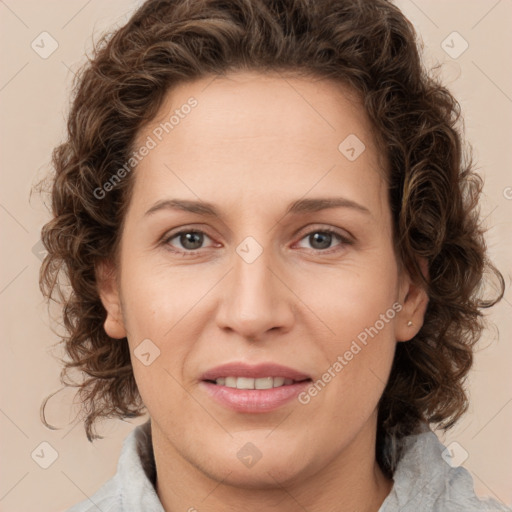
[67,420,512,512]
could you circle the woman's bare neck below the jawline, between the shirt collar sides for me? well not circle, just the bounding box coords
[152,416,393,512]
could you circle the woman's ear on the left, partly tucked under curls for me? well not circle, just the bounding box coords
[96,262,126,339]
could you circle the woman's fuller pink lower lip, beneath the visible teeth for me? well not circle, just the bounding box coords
[201,380,311,413]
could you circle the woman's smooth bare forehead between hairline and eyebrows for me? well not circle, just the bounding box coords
[129,72,384,216]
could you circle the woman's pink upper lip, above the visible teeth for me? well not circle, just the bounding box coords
[201,362,311,381]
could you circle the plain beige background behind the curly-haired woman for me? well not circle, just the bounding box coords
[0,0,512,512]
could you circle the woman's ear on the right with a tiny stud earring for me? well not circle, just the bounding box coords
[395,258,429,341]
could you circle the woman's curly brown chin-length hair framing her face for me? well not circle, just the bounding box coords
[40,0,504,475]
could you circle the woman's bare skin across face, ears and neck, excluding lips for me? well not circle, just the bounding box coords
[98,72,428,512]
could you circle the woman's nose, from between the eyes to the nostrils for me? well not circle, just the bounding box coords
[217,242,295,341]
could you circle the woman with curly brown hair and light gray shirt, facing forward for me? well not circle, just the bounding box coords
[41,0,507,512]
